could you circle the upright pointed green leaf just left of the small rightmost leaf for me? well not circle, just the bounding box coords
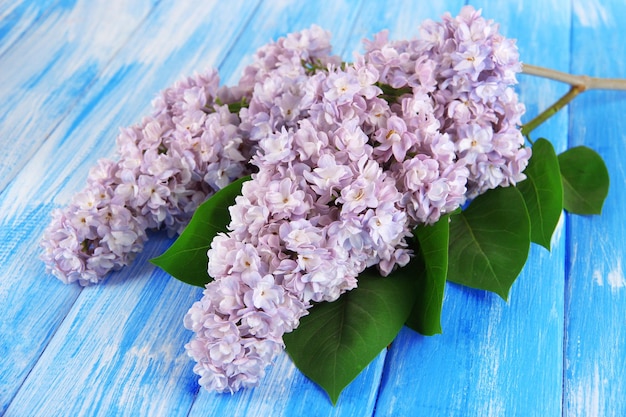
[517,139,563,250]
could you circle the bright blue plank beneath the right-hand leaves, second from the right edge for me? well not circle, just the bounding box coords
[376,1,570,416]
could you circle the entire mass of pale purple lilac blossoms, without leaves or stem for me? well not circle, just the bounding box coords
[42,7,530,392]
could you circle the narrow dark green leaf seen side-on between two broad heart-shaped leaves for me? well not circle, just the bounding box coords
[405,216,450,336]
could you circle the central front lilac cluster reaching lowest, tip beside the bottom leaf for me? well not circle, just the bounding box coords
[185,64,410,391]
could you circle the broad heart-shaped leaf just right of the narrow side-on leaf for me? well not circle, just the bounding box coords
[448,187,530,300]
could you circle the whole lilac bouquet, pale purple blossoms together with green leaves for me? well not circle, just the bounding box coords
[42,6,608,402]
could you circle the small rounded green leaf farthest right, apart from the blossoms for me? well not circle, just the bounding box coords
[559,146,609,214]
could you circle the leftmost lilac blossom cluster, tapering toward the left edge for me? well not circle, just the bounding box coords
[41,70,253,285]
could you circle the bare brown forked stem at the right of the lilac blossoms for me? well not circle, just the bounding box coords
[521,64,626,136]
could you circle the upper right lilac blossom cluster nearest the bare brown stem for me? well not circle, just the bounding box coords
[363,6,531,224]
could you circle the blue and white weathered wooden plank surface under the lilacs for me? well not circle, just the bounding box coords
[0,0,626,417]
